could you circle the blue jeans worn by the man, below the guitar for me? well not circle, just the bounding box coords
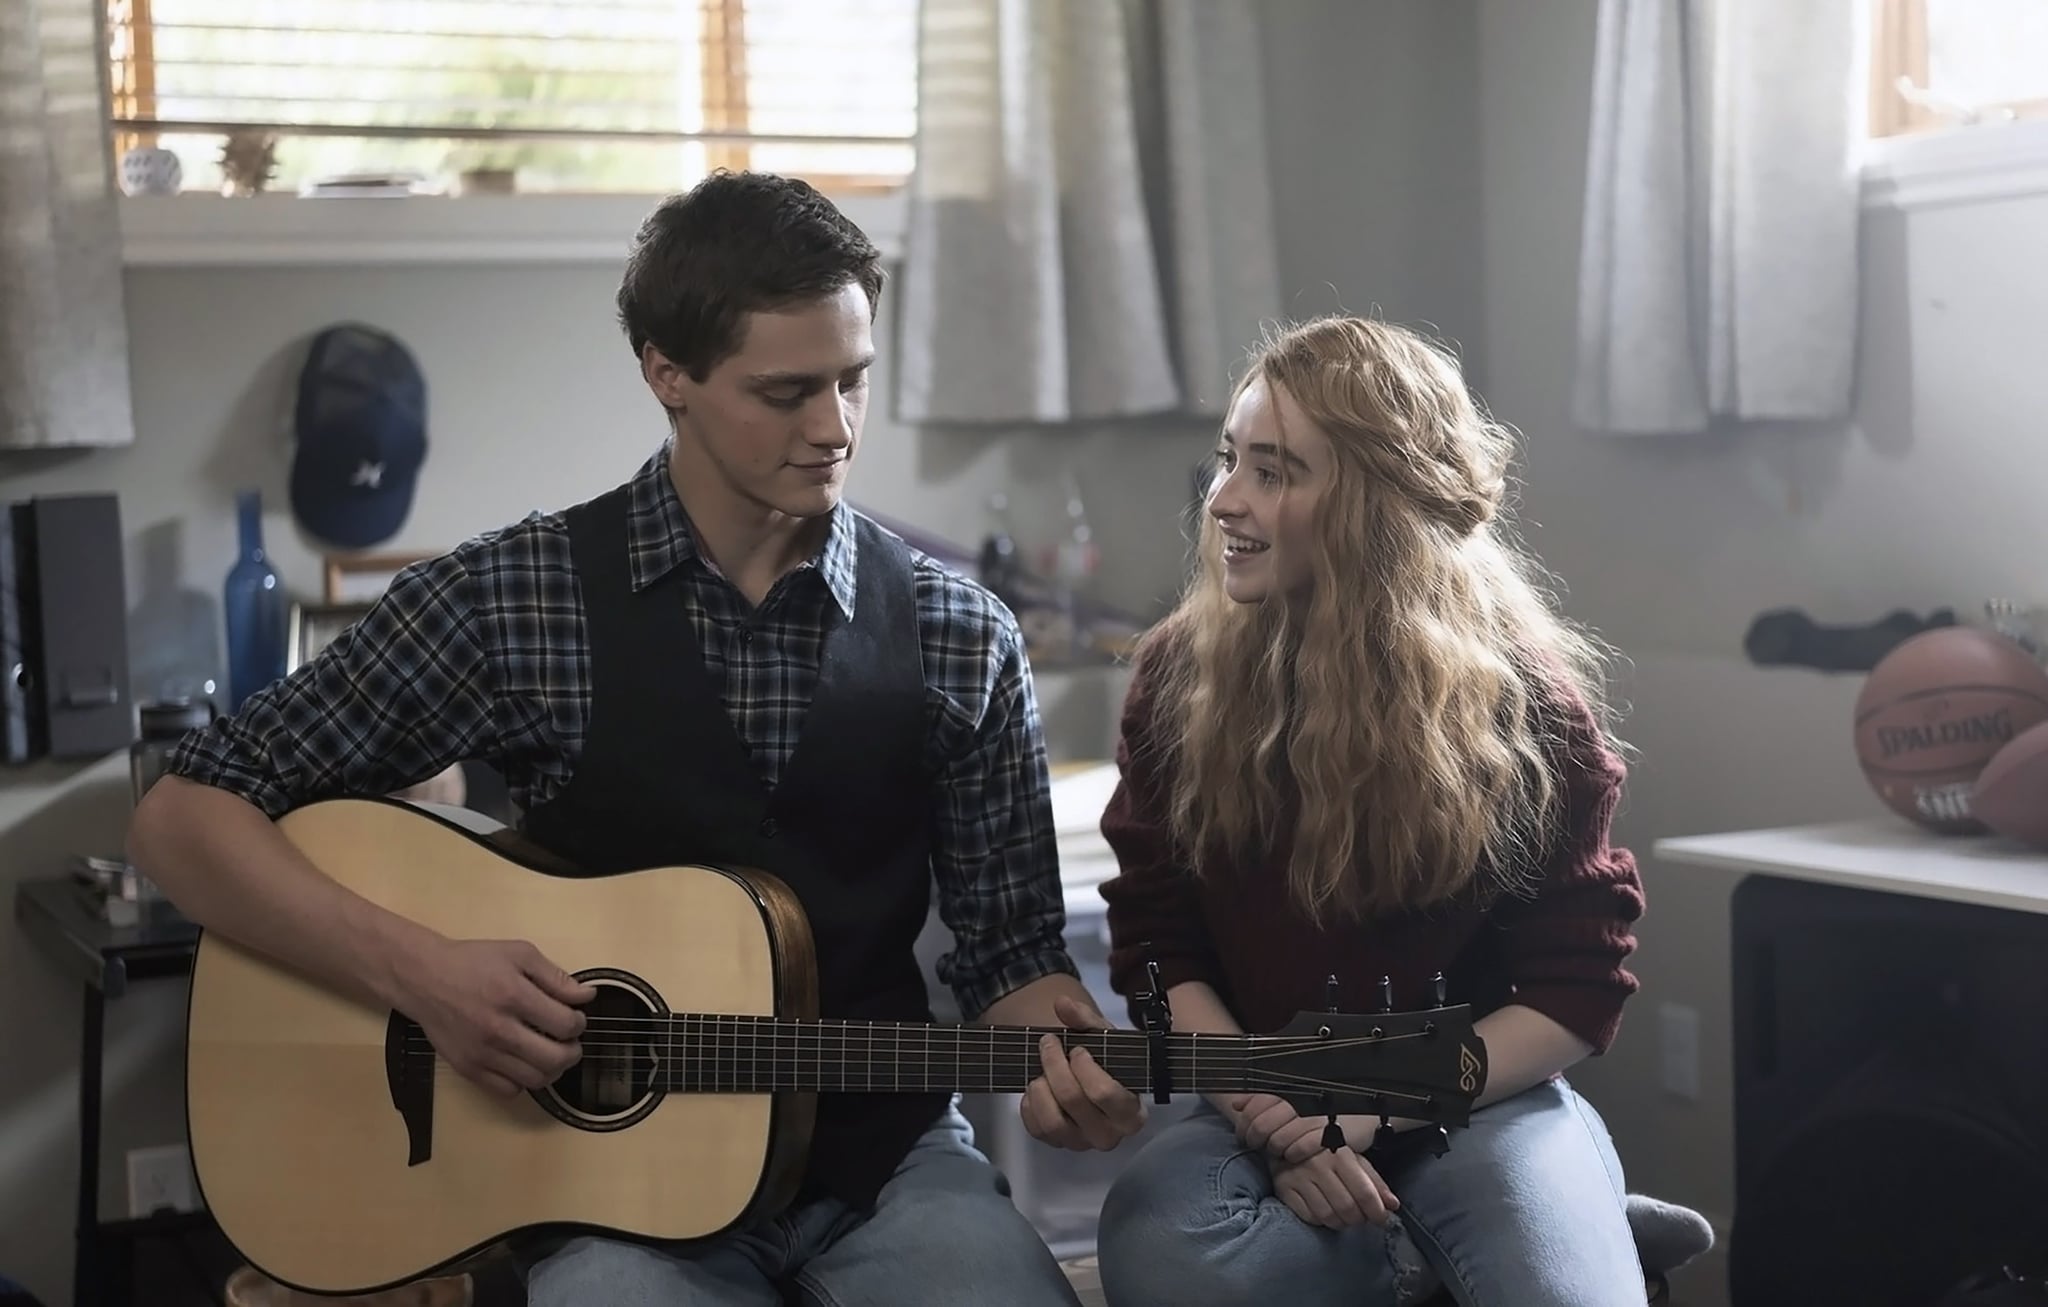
[526,1108,1079,1307]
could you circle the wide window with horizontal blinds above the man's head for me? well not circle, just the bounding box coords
[109,0,918,195]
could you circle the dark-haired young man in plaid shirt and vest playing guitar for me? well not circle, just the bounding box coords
[129,174,1145,1307]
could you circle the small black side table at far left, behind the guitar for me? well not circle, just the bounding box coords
[14,877,207,1307]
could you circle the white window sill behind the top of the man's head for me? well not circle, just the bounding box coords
[121,193,905,268]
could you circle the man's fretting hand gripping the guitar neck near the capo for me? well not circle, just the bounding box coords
[981,975,1145,1151]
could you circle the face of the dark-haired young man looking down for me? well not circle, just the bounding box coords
[647,285,874,518]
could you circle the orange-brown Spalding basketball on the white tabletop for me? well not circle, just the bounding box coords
[1855,627,2048,834]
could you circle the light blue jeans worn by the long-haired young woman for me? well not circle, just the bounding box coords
[1098,1080,1647,1307]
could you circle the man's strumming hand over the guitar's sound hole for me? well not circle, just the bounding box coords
[395,936,596,1098]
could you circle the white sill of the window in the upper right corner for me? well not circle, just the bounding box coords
[1864,119,2048,209]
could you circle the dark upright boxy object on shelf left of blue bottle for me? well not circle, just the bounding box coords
[0,494,135,762]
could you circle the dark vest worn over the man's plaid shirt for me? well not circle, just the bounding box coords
[524,488,948,1207]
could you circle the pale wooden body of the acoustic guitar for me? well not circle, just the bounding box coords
[186,799,815,1293]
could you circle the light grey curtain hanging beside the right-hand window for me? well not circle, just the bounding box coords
[1573,0,1868,434]
